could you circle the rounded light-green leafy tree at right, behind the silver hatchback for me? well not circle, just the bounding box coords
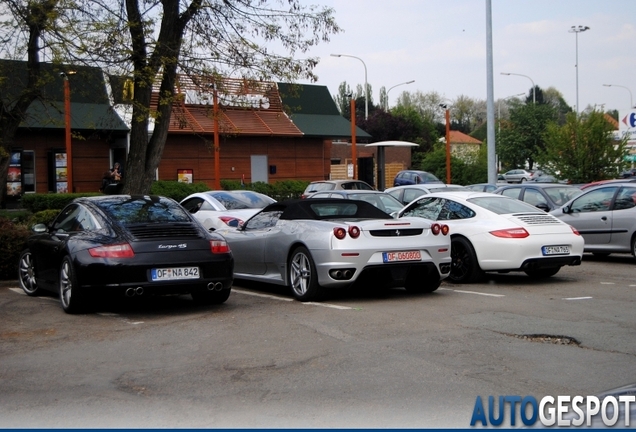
[538,111,627,183]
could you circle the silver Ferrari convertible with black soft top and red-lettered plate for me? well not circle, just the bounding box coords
[217,198,451,301]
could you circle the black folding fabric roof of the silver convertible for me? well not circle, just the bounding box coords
[262,198,393,220]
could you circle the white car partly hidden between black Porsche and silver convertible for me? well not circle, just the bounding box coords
[181,190,276,231]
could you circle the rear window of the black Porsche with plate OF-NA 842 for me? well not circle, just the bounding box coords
[94,196,190,225]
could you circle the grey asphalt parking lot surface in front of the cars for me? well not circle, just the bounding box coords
[0,254,636,428]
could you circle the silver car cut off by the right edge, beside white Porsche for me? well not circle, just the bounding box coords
[550,183,636,257]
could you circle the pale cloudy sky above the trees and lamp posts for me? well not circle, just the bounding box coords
[302,0,636,111]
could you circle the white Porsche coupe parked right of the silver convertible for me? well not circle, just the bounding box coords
[398,191,583,283]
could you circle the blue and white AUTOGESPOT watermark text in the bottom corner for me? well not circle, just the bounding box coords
[470,395,636,427]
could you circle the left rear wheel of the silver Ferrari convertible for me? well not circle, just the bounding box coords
[287,246,324,302]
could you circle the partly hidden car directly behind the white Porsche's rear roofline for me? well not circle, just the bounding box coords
[493,182,581,212]
